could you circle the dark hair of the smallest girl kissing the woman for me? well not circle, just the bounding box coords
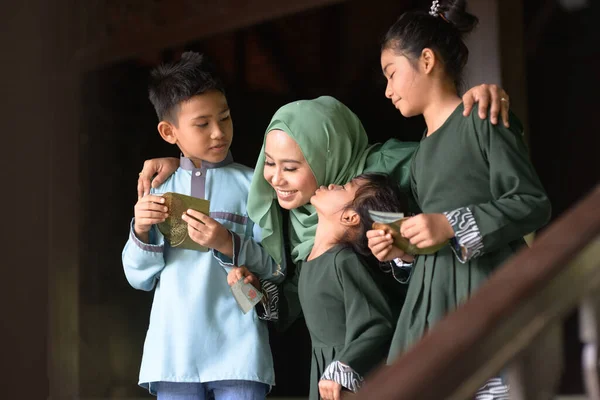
[342,173,408,257]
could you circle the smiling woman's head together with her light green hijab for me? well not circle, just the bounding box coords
[248,96,417,263]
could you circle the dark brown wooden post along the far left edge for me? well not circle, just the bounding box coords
[0,0,79,399]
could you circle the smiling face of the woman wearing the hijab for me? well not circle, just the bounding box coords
[263,130,317,210]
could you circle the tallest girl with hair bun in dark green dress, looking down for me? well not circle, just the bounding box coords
[369,1,550,399]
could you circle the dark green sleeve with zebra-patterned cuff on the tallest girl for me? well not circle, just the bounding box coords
[454,110,551,258]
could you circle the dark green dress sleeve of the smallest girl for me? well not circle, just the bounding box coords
[335,252,393,376]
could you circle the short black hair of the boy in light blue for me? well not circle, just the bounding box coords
[148,51,225,125]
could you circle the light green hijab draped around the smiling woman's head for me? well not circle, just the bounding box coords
[248,96,416,264]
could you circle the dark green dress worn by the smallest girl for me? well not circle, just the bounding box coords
[298,245,395,399]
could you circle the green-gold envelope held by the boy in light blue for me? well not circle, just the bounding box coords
[158,192,210,251]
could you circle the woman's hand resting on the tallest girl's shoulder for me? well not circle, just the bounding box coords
[463,84,510,128]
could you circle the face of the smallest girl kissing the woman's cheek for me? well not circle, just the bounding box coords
[310,179,361,221]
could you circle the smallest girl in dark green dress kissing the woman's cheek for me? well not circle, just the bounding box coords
[228,173,406,400]
